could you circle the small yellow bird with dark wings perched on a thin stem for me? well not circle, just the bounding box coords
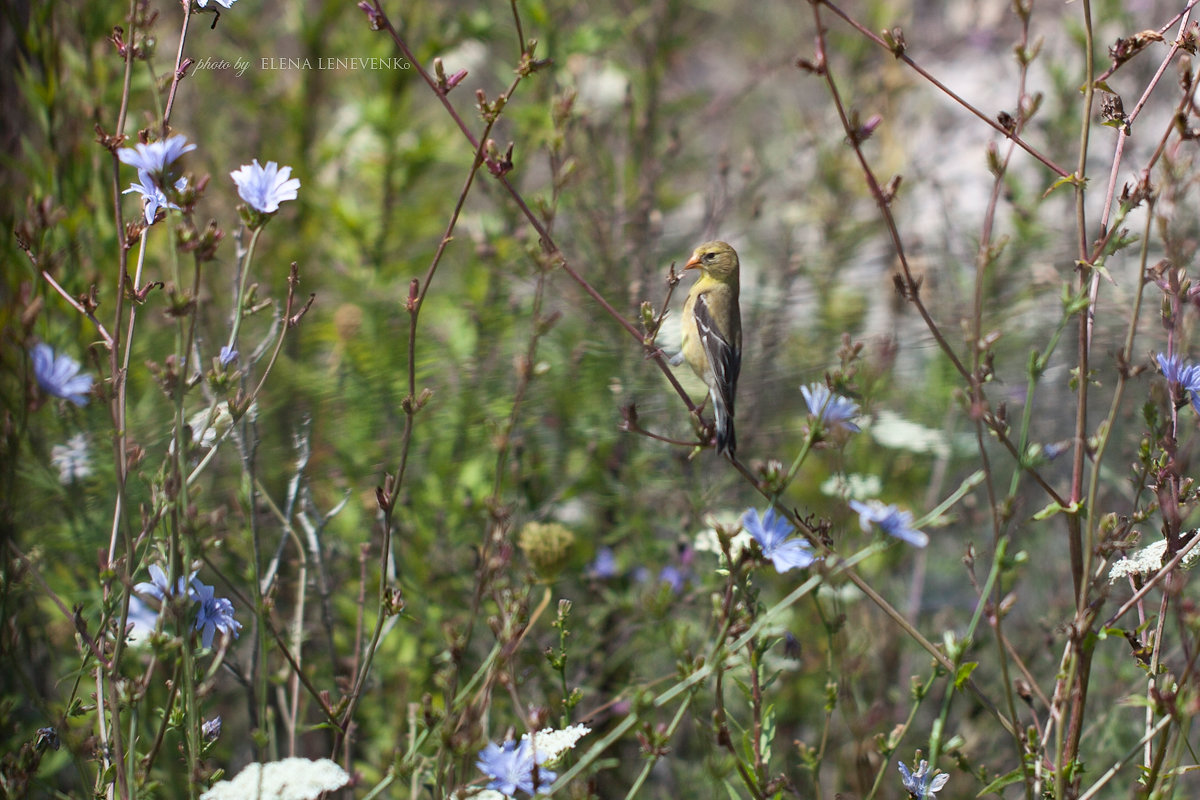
[680,241,742,456]
